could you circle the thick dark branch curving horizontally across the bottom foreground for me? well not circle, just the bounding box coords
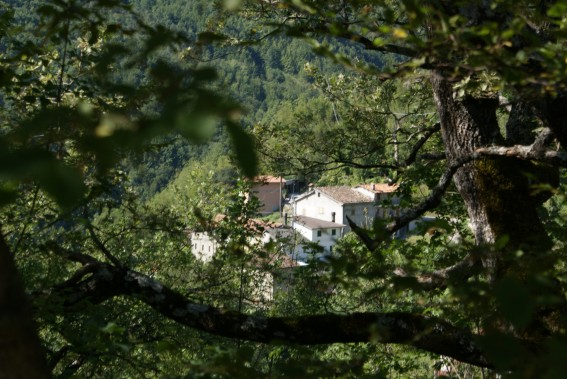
[46,256,494,367]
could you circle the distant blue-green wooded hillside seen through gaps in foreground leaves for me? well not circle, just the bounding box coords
[7,1,360,199]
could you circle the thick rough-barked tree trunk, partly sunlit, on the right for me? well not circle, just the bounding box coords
[431,72,550,262]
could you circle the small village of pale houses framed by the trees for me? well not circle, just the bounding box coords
[189,176,431,301]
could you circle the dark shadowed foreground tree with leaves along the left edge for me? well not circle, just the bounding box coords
[0,1,255,378]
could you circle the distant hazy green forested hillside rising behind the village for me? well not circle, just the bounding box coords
[126,1,392,198]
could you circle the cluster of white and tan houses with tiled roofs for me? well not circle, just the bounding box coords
[191,176,399,263]
